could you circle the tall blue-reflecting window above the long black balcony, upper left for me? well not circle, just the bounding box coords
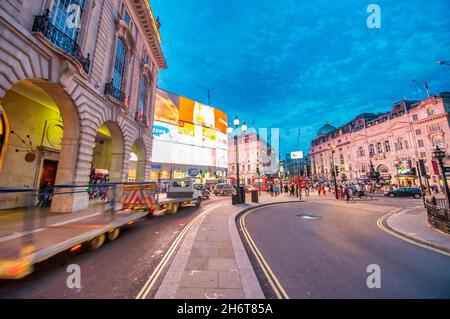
[50,0,84,42]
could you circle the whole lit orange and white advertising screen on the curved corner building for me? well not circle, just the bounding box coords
[152,89,228,168]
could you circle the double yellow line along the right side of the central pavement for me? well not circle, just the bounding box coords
[239,208,289,299]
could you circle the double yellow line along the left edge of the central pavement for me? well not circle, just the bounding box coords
[136,205,218,299]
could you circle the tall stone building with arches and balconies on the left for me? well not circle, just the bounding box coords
[0,0,167,212]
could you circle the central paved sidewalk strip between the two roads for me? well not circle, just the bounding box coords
[154,194,299,299]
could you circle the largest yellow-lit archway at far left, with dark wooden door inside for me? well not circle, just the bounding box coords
[0,79,82,212]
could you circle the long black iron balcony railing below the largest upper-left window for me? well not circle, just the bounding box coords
[32,9,91,73]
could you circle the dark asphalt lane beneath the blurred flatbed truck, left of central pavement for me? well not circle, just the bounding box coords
[0,196,231,298]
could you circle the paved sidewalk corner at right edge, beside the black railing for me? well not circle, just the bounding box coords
[386,208,450,252]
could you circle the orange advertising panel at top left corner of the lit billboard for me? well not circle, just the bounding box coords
[154,89,180,125]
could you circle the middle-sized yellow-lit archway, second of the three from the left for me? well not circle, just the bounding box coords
[90,121,124,183]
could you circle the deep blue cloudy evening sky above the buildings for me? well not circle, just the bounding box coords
[150,0,450,155]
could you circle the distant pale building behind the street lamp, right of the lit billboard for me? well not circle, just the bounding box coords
[228,128,279,185]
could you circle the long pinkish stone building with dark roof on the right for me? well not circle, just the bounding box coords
[309,92,450,186]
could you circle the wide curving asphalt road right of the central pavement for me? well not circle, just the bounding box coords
[241,199,450,298]
